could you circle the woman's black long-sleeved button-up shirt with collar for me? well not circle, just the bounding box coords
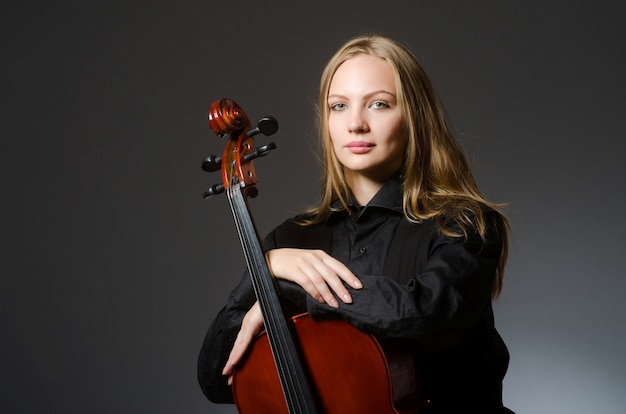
[198,178,509,413]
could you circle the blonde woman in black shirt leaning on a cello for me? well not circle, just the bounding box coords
[198,36,510,413]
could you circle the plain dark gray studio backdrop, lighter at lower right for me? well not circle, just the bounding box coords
[0,0,626,414]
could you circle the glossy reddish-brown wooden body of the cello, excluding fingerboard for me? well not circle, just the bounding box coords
[233,314,421,414]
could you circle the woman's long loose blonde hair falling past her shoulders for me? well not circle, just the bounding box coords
[308,35,508,298]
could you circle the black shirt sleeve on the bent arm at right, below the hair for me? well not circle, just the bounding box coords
[307,217,502,350]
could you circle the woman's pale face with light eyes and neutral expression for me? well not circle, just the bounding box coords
[328,55,406,182]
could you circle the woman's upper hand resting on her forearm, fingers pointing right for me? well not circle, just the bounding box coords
[266,249,363,308]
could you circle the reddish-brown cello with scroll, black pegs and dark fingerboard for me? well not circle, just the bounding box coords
[202,98,423,414]
